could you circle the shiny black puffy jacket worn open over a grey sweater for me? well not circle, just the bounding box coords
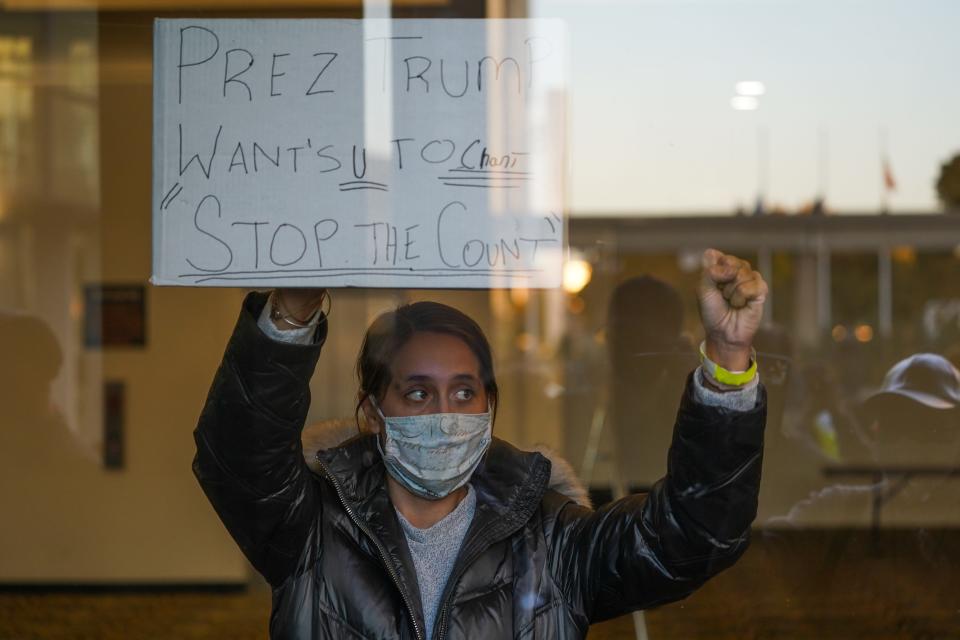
[194,293,765,640]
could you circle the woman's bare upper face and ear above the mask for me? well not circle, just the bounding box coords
[364,333,488,431]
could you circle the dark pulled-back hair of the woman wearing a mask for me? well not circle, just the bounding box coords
[357,301,499,430]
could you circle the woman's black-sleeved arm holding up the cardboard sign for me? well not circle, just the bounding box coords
[193,290,327,585]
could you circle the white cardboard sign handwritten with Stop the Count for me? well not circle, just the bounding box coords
[151,19,567,288]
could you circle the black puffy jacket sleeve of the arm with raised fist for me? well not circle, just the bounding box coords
[546,370,766,624]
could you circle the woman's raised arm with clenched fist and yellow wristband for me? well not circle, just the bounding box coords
[545,249,767,622]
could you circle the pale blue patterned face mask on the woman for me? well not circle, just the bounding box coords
[370,397,492,500]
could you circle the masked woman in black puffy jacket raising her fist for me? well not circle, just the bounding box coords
[194,250,766,640]
